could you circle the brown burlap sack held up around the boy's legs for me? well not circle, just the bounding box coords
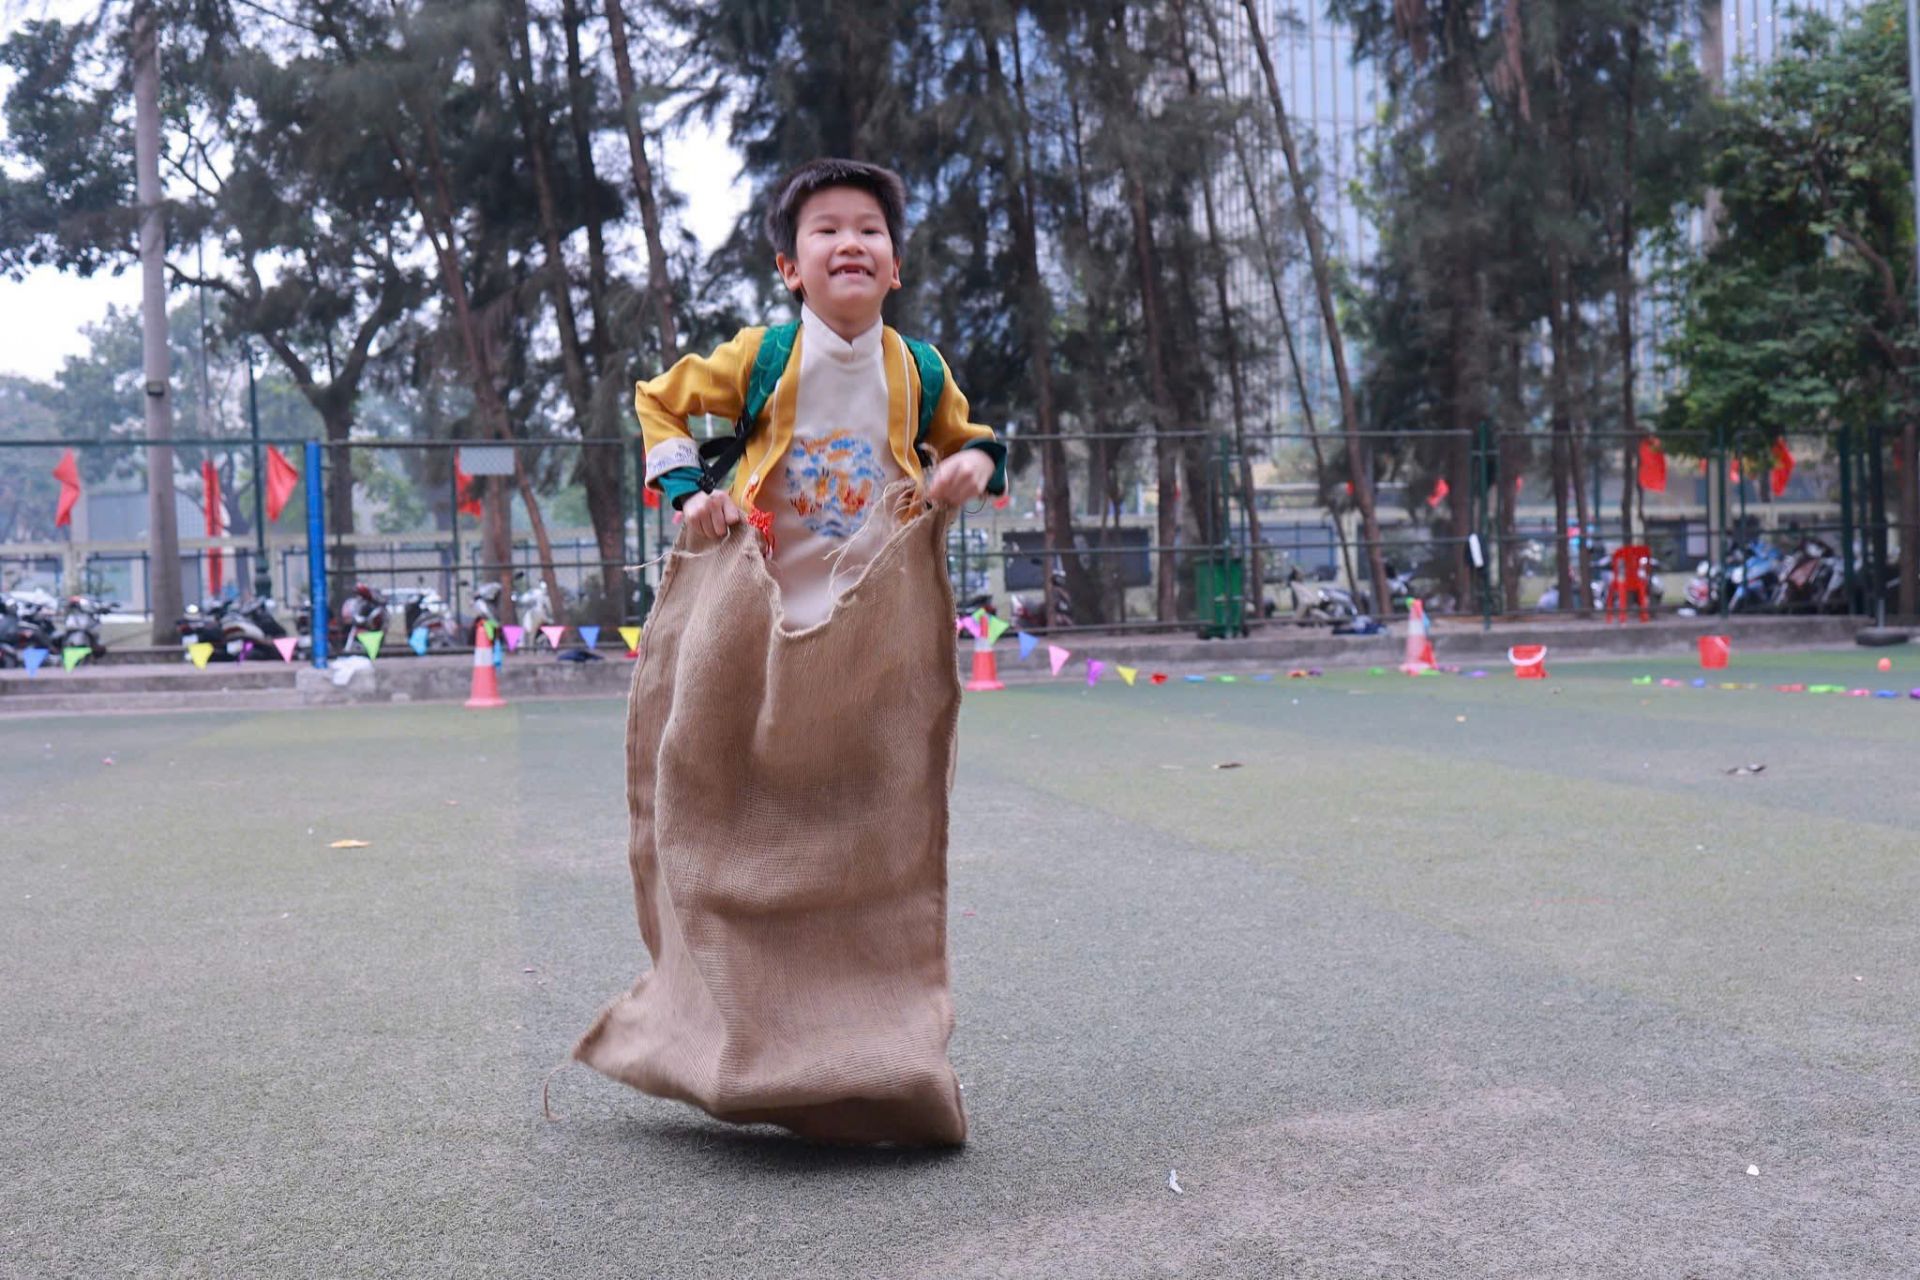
[574,512,966,1144]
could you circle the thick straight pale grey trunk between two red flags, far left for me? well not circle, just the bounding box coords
[132,0,184,645]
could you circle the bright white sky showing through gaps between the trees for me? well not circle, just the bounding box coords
[0,0,747,380]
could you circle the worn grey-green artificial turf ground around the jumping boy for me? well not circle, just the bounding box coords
[0,651,1920,1280]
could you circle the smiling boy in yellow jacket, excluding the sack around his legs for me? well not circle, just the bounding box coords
[634,159,1006,629]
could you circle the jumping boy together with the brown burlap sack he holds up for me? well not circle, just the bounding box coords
[574,159,1006,1144]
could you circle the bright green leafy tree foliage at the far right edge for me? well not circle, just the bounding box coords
[1663,0,1916,459]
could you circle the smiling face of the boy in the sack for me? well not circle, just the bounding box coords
[774,186,900,338]
